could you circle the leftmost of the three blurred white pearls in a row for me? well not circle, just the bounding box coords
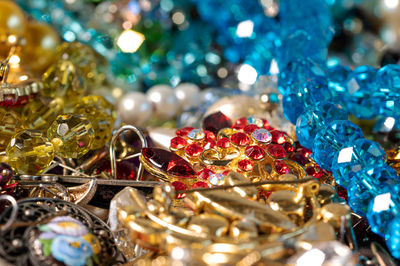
[117,92,153,126]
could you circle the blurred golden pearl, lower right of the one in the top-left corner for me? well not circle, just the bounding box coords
[22,21,60,72]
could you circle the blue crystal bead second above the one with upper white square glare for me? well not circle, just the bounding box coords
[282,77,332,124]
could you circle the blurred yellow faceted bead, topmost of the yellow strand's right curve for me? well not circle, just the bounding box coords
[58,42,107,89]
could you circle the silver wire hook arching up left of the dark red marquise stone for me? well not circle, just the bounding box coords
[110,125,147,181]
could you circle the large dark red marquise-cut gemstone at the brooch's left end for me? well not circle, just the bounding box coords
[142,148,196,178]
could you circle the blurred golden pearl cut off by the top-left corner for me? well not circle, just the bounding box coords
[0,0,26,36]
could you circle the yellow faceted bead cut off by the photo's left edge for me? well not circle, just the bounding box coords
[0,108,23,151]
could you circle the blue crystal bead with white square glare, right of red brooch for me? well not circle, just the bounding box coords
[332,139,387,188]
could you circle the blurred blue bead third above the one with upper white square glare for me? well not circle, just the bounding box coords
[278,58,325,95]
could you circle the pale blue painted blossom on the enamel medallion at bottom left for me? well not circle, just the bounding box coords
[51,235,93,266]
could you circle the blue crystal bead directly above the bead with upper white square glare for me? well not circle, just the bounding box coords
[296,102,347,149]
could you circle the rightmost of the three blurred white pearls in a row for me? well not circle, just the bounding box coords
[175,83,200,110]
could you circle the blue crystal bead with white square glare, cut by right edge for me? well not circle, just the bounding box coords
[367,184,400,236]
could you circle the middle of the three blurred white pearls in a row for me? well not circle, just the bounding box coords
[147,85,179,120]
